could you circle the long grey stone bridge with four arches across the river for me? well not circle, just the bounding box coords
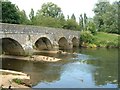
[0,23,80,55]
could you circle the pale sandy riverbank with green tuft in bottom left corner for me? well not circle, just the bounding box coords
[0,69,30,89]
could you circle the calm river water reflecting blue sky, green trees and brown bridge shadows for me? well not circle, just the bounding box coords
[2,48,118,88]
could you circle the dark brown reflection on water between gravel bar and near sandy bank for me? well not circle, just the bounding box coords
[2,59,61,84]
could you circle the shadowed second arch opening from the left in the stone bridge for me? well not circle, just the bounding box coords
[35,37,53,50]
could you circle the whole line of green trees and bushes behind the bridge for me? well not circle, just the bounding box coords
[0,0,120,35]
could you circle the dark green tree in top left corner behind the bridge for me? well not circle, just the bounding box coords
[1,1,20,24]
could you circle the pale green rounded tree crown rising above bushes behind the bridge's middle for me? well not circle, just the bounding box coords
[37,2,62,18]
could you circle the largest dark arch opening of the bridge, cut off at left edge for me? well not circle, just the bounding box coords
[0,38,25,55]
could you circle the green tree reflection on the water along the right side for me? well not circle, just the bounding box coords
[81,49,118,85]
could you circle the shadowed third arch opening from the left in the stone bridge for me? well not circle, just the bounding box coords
[58,37,68,50]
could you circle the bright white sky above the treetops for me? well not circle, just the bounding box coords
[9,0,116,19]
